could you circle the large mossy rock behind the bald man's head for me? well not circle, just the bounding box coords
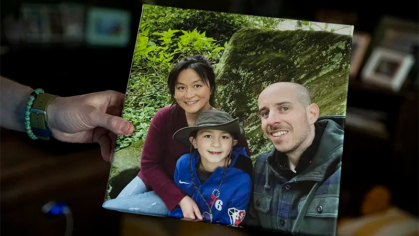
[215,28,352,158]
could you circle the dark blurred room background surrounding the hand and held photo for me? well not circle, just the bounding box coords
[0,0,419,236]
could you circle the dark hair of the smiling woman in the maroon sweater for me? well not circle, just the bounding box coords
[167,55,215,106]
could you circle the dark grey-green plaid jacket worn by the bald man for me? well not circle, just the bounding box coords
[247,116,344,235]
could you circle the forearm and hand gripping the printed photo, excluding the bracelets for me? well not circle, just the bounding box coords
[0,76,134,161]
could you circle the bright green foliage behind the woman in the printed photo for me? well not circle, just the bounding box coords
[115,5,290,152]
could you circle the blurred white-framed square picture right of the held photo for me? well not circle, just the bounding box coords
[362,47,414,92]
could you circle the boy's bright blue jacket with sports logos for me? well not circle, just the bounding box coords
[169,147,253,226]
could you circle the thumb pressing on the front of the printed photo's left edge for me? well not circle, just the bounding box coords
[93,113,134,135]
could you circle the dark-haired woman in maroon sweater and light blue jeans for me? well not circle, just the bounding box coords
[103,55,250,220]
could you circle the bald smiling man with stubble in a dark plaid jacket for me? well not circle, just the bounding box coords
[248,82,344,235]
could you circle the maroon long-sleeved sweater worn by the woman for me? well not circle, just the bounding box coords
[138,105,250,211]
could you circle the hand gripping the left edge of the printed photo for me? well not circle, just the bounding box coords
[47,91,134,161]
